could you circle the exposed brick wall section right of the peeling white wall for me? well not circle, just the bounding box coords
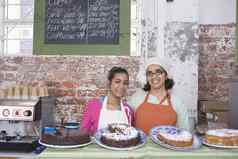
[198,24,235,102]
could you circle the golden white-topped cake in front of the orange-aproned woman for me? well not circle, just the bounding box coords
[157,126,193,147]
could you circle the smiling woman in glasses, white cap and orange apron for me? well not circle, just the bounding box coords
[129,58,189,134]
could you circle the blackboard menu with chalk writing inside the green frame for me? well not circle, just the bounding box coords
[45,0,120,44]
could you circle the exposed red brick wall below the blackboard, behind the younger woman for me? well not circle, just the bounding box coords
[0,56,139,121]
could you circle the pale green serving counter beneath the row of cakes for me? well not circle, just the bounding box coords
[37,139,238,159]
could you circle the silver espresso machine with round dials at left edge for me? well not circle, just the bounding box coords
[0,98,41,151]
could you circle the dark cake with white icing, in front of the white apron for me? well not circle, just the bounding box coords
[101,123,140,148]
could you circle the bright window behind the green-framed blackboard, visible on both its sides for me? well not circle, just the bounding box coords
[0,0,139,56]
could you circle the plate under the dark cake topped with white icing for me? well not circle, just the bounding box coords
[95,129,146,151]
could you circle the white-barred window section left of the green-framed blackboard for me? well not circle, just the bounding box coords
[0,0,34,55]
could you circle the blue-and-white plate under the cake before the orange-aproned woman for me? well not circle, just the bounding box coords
[150,126,202,151]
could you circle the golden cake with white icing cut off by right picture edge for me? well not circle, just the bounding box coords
[204,129,238,146]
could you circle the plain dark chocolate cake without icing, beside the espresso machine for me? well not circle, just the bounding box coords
[41,127,90,146]
